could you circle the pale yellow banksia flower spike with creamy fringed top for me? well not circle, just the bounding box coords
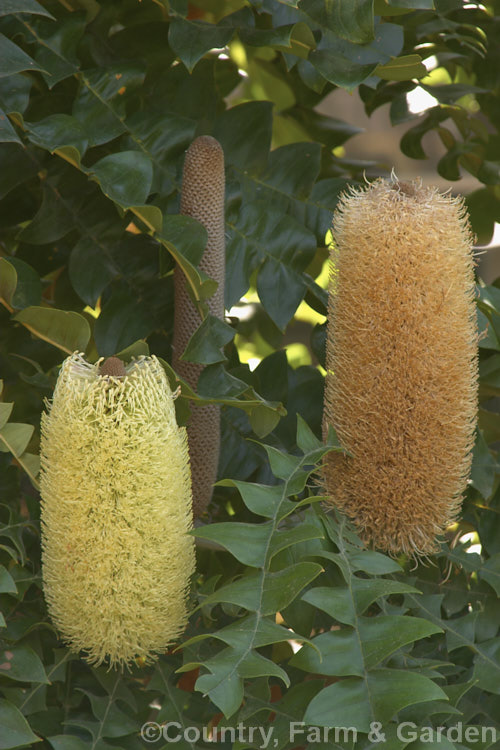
[41,354,194,666]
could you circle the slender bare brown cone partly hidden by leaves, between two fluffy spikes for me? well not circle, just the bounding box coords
[173,135,225,518]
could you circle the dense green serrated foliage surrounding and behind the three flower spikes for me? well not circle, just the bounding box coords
[0,0,500,750]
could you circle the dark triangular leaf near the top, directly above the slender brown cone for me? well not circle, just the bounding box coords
[168,16,234,73]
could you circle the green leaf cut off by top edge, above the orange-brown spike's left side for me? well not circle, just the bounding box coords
[298,0,374,44]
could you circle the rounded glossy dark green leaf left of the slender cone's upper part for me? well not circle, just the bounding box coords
[89,151,153,209]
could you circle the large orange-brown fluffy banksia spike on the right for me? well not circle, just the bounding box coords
[324,180,478,555]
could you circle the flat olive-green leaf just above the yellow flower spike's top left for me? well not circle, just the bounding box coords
[14,307,90,354]
